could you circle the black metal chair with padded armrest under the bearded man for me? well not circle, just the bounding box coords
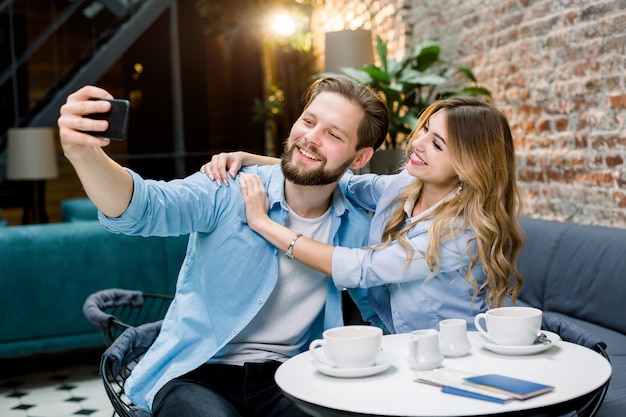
[83,288,174,417]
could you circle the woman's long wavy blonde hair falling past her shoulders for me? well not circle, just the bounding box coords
[378,97,524,307]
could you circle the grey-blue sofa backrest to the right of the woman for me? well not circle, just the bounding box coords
[518,218,626,334]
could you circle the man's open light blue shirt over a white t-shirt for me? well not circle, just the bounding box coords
[99,165,371,409]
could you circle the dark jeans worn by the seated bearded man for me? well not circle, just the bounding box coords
[152,362,307,417]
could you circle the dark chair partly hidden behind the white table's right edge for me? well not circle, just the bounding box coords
[541,312,611,417]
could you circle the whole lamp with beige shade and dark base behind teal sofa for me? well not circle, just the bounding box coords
[7,127,58,223]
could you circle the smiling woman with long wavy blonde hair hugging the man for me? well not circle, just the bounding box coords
[203,97,523,333]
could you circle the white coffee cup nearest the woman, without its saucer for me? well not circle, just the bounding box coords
[474,307,543,346]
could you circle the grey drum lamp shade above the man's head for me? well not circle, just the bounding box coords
[324,29,374,73]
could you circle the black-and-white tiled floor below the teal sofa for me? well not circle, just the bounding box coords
[0,352,113,417]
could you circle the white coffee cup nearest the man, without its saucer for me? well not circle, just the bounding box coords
[309,325,383,368]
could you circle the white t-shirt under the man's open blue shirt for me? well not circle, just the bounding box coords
[209,209,331,365]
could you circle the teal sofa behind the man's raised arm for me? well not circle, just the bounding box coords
[0,214,188,358]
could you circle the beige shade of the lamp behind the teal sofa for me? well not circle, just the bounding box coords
[7,127,58,180]
